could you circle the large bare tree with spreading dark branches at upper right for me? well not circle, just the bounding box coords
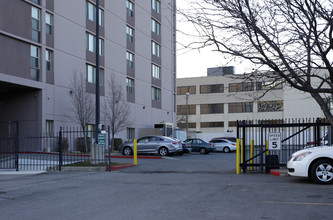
[180,0,333,125]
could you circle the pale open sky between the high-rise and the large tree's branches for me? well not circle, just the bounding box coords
[177,0,246,78]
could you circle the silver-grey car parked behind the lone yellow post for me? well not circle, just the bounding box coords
[119,135,183,156]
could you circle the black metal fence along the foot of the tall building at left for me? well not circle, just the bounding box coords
[0,122,110,171]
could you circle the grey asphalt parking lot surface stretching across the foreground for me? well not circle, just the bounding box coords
[0,153,333,219]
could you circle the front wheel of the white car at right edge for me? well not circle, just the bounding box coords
[311,159,333,184]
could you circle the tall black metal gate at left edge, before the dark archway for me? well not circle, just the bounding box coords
[0,121,19,170]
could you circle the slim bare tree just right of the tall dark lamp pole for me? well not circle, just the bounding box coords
[104,75,133,150]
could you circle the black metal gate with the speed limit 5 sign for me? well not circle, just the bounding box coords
[237,119,332,173]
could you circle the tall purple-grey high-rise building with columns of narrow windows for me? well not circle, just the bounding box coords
[0,0,176,139]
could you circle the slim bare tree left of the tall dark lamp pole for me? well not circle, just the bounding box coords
[70,73,95,152]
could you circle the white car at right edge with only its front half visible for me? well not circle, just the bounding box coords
[287,146,333,184]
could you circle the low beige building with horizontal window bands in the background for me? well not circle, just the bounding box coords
[177,71,324,136]
